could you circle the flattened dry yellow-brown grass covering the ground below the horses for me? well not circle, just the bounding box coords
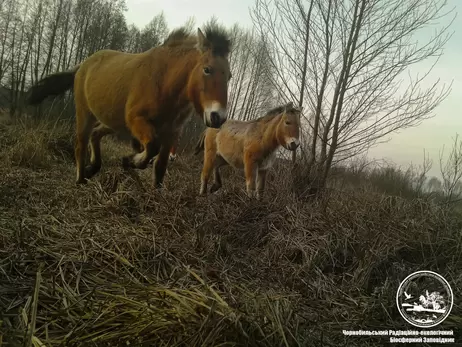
[0,115,462,346]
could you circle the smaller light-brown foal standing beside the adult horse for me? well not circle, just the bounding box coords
[195,102,301,199]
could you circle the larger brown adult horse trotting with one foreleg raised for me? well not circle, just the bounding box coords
[28,24,231,188]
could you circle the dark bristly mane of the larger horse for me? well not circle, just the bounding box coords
[162,21,232,56]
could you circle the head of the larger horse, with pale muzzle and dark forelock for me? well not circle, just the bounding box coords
[192,27,231,128]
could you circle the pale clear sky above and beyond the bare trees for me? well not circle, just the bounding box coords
[126,0,462,177]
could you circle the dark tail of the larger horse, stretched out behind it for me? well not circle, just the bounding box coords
[26,64,80,105]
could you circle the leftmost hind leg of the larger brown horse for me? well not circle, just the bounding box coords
[75,109,96,184]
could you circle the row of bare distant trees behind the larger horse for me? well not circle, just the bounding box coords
[0,0,274,119]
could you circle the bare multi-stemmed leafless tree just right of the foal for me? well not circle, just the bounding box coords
[252,0,453,186]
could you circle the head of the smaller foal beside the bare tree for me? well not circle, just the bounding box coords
[277,103,302,151]
